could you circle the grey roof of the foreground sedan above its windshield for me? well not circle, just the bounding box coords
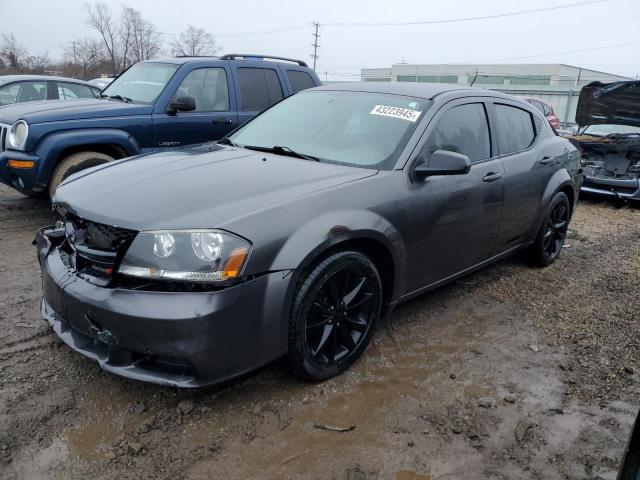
[313,82,521,100]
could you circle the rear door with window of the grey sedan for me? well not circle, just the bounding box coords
[490,99,557,252]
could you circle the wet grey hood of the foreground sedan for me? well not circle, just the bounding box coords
[54,144,377,230]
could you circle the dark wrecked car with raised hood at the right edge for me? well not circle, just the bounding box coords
[571,80,640,201]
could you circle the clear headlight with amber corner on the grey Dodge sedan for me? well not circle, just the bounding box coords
[118,230,251,283]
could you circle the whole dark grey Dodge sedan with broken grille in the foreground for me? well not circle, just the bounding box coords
[35,83,582,387]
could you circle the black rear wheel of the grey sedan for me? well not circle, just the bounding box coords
[529,192,571,267]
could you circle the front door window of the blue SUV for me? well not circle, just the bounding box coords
[173,68,229,112]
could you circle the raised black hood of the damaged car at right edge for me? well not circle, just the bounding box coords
[576,80,640,127]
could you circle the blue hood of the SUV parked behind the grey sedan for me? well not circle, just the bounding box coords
[0,98,153,125]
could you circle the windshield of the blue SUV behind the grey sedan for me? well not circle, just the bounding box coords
[102,62,180,103]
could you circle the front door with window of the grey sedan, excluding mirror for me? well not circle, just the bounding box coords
[407,99,504,292]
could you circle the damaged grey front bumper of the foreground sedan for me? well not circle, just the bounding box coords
[34,227,292,387]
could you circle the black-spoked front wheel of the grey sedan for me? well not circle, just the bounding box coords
[289,251,382,380]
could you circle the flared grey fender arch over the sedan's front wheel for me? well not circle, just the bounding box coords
[271,209,406,299]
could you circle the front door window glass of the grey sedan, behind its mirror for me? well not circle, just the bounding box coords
[422,103,491,162]
